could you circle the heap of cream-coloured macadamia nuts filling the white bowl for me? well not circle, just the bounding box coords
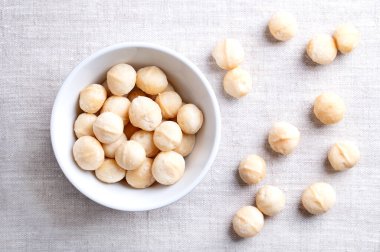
[73,63,203,188]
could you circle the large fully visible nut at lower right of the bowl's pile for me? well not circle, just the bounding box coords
[152,151,185,185]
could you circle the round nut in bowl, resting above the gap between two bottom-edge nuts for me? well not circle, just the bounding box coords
[115,140,146,170]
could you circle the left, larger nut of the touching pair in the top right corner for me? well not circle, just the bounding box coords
[306,34,337,65]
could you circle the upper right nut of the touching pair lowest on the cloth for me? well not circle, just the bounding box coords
[256,185,286,216]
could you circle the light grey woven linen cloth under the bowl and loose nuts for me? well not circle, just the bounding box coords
[0,0,380,251]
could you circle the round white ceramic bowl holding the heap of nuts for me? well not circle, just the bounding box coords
[50,43,221,211]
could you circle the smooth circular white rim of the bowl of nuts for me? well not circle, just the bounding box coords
[50,42,221,212]
